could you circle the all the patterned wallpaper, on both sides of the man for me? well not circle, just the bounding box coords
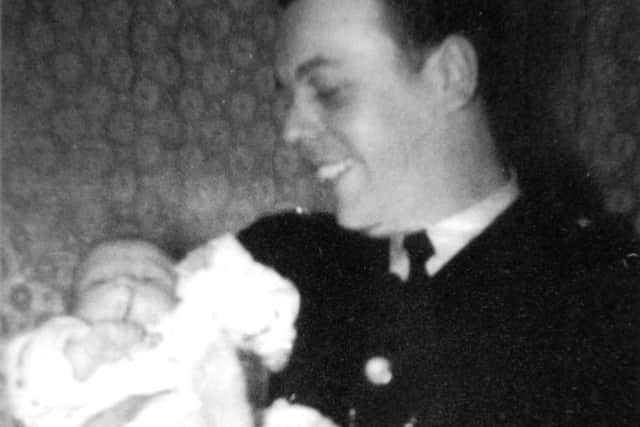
[0,0,640,425]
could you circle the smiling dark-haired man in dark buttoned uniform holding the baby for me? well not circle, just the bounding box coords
[240,0,640,427]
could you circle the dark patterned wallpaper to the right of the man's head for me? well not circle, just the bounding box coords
[531,0,640,221]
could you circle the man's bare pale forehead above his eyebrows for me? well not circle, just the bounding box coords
[277,0,393,74]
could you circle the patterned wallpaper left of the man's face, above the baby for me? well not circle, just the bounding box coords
[2,0,317,324]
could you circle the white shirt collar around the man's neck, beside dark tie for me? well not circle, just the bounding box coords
[389,174,520,279]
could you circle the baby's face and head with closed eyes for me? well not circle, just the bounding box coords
[74,240,176,325]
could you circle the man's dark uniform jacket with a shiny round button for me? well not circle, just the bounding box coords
[239,196,640,427]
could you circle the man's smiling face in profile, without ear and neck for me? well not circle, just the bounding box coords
[276,0,444,235]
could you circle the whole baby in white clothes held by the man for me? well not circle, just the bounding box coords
[7,236,299,427]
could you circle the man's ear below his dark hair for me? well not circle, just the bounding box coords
[423,34,478,111]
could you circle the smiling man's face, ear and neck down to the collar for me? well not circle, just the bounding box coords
[277,1,507,235]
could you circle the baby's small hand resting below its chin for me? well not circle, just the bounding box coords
[64,320,146,381]
